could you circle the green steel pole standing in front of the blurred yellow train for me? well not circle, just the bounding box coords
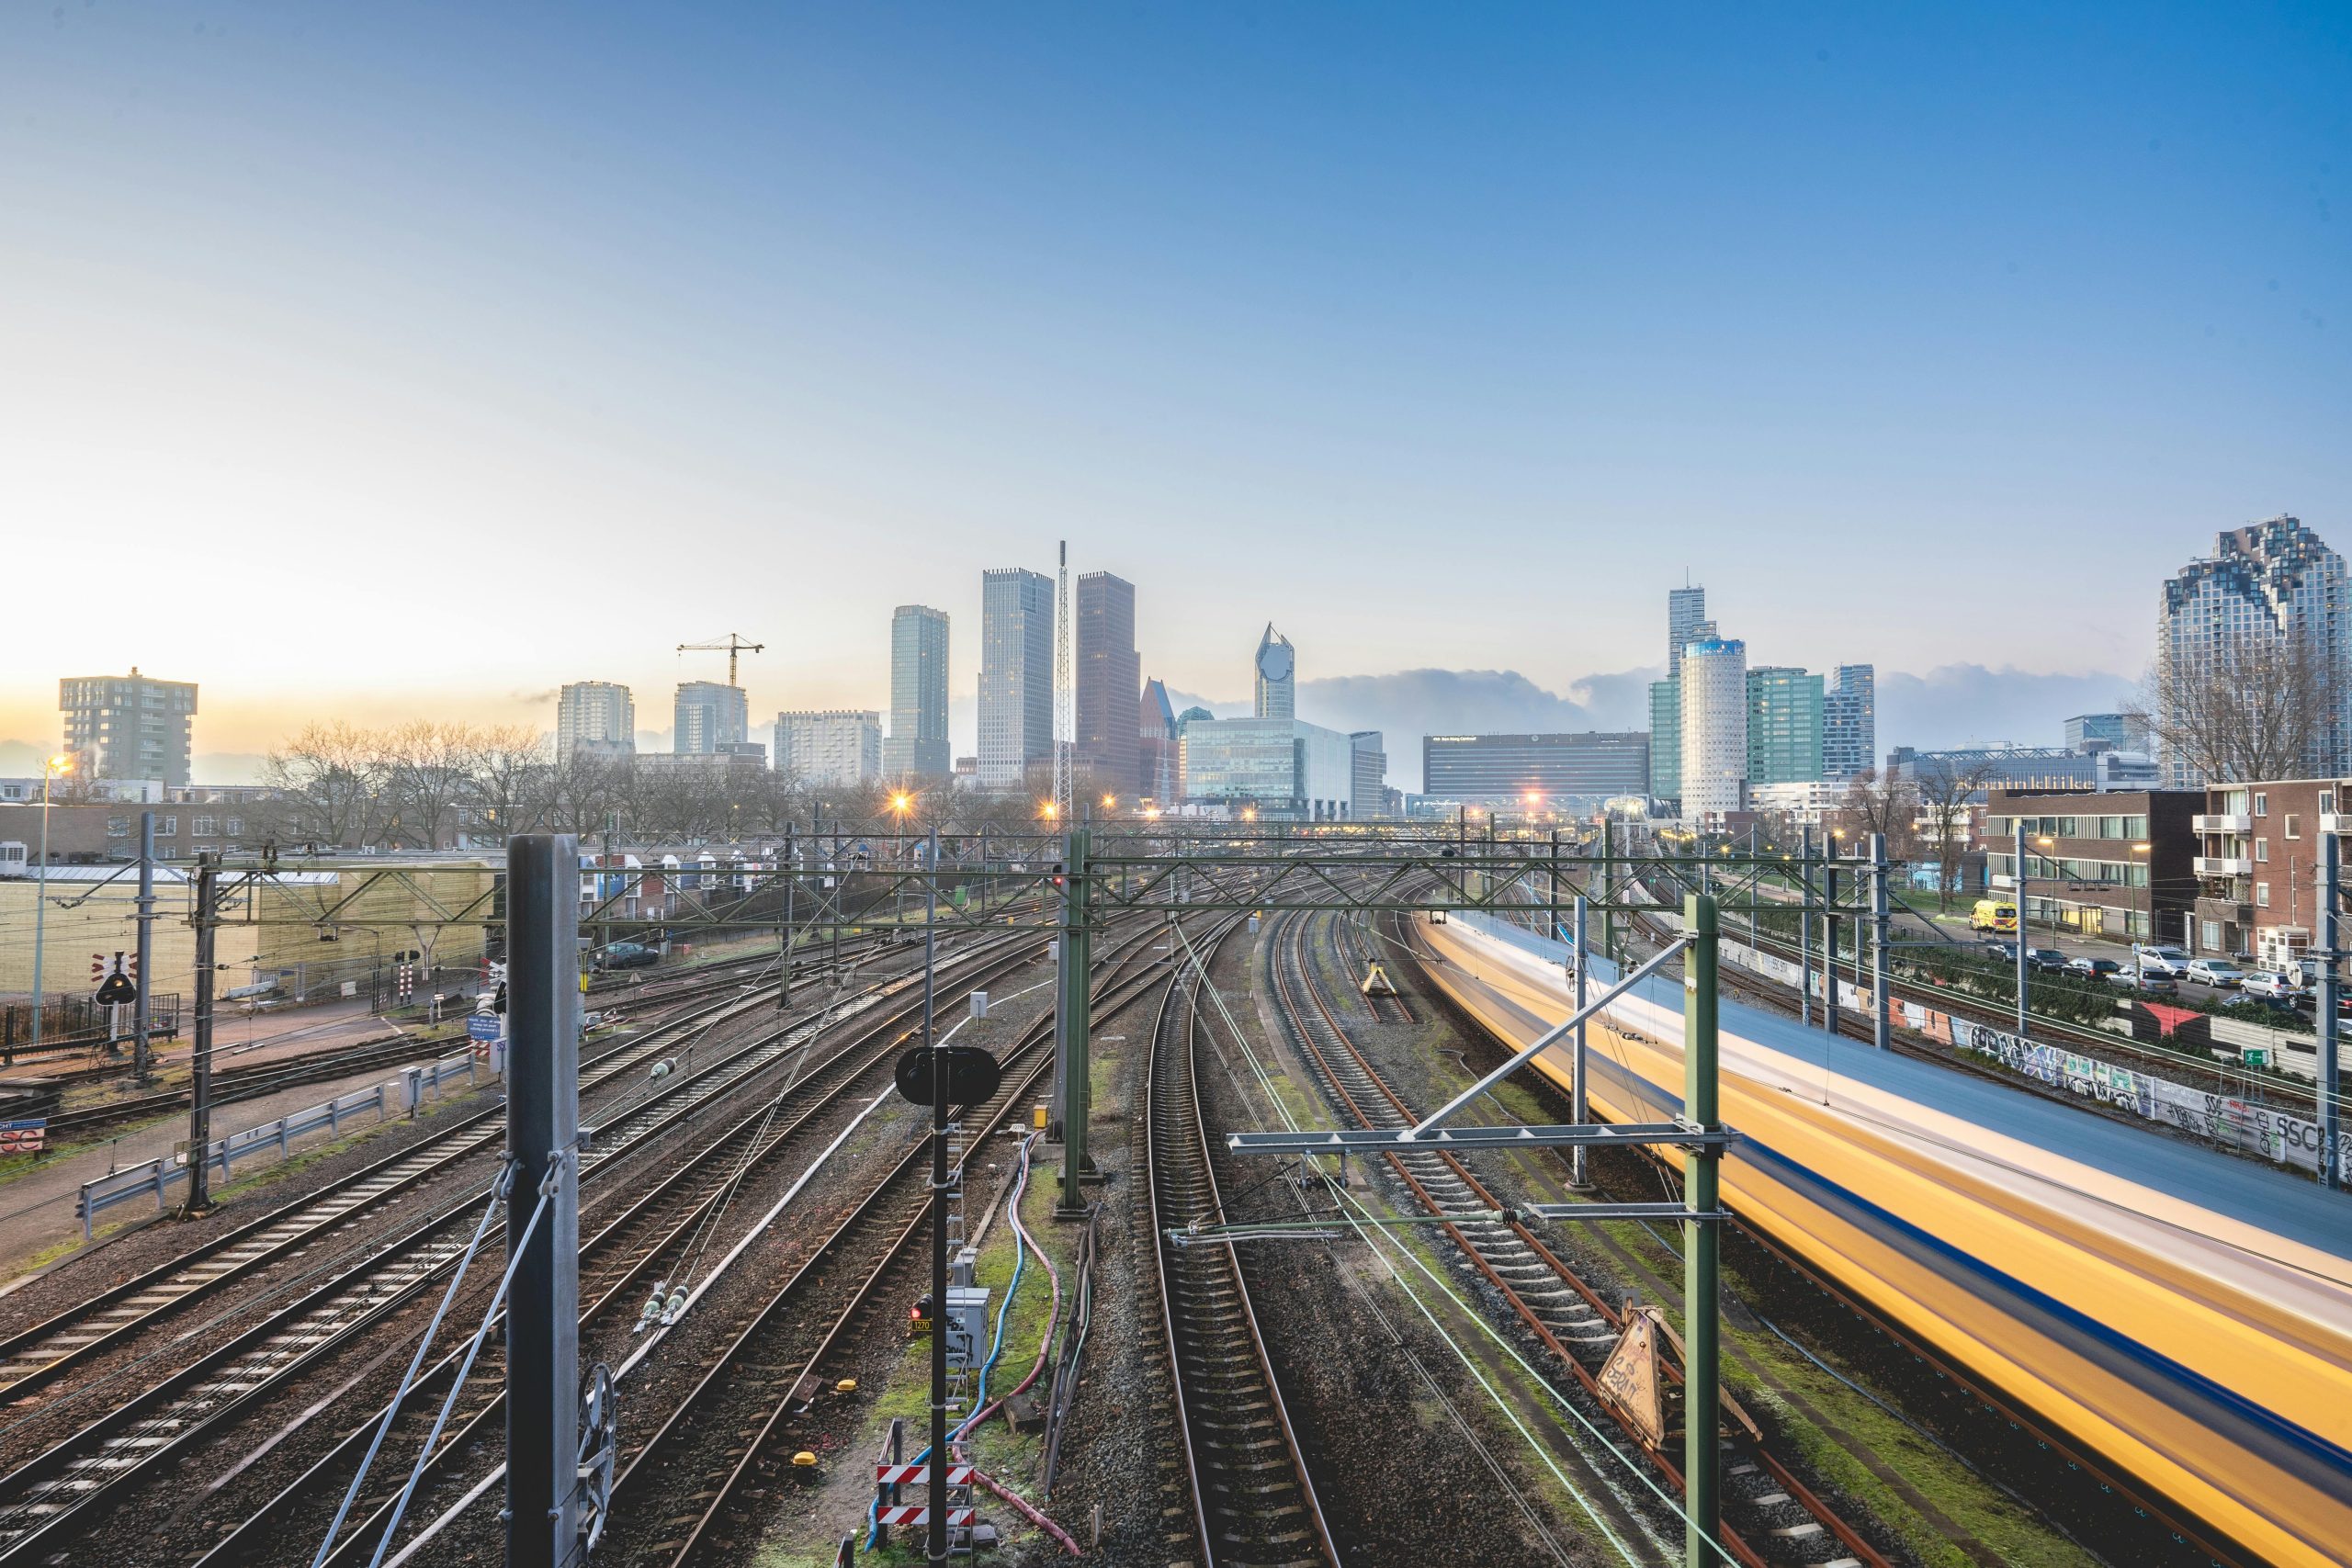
[1681,894,1722,1568]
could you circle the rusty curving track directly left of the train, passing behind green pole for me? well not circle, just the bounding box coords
[1270,917,1891,1568]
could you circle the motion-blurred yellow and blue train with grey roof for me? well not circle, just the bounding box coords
[1419,912,2352,1563]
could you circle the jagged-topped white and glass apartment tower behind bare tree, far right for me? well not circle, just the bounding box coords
[2157,514,2352,790]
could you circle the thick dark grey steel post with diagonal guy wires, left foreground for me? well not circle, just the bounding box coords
[505,832,581,1568]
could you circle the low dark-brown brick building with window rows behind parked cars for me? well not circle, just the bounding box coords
[1978,790,2191,952]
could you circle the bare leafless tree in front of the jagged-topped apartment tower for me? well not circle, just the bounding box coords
[2126,637,2345,783]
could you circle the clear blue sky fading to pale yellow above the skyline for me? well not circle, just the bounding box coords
[0,0,2352,784]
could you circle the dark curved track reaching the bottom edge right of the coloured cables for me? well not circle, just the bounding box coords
[1146,921,1339,1568]
